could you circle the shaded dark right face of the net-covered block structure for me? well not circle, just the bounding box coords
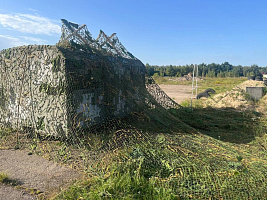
[61,48,145,129]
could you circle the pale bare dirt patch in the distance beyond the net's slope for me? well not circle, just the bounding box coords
[159,85,192,103]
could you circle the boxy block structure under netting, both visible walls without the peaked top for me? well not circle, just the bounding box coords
[0,45,145,136]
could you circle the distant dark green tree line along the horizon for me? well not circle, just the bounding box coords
[146,62,267,77]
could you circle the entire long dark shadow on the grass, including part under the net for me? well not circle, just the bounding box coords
[126,108,266,144]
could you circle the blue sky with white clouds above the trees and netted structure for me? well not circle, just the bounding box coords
[0,0,267,67]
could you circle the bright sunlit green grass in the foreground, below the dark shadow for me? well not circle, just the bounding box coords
[55,130,267,199]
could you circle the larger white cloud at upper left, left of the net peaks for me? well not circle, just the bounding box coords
[0,14,61,35]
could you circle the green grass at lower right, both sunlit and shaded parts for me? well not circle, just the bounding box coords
[51,103,267,199]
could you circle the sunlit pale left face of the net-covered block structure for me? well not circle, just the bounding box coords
[0,45,67,135]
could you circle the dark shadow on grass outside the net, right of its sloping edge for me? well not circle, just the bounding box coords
[170,108,265,144]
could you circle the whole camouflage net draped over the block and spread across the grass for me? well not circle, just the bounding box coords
[0,20,267,199]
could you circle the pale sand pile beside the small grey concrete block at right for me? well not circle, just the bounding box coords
[205,80,266,108]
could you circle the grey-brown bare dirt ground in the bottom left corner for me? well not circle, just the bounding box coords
[0,150,80,200]
